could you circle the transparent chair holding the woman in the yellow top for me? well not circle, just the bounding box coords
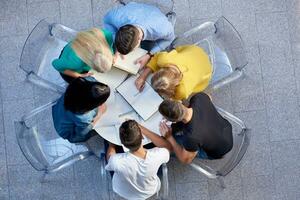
[169,17,248,92]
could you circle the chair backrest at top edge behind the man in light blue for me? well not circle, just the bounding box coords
[118,0,174,15]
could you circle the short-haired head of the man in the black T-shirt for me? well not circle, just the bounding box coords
[158,99,186,122]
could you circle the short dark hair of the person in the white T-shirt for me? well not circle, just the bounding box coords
[120,120,143,152]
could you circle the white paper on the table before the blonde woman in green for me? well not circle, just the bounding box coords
[92,67,128,91]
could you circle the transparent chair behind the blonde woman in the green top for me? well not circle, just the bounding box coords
[20,19,76,93]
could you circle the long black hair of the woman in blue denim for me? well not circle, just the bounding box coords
[64,77,110,114]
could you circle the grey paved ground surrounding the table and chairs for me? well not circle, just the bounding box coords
[0,0,300,200]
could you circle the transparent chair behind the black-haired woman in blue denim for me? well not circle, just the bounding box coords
[15,102,91,172]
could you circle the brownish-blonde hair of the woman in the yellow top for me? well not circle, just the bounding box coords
[151,67,182,99]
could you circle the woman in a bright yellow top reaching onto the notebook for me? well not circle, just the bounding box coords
[135,45,212,100]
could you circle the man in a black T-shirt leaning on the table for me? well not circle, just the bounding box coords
[159,93,233,164]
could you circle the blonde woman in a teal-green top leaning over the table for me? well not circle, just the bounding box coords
[52,28,113,83]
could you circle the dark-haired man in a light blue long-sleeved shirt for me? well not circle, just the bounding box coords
[103,2,175,67]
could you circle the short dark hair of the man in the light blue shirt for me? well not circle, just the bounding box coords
[115,24,139,55]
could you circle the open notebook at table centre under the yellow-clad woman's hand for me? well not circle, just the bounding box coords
[116,75,163,121]
